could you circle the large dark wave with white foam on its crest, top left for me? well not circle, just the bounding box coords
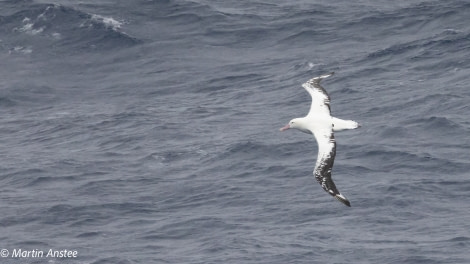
[0,4,141,54]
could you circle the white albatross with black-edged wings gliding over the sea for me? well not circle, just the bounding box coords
[280,72,360,206]
